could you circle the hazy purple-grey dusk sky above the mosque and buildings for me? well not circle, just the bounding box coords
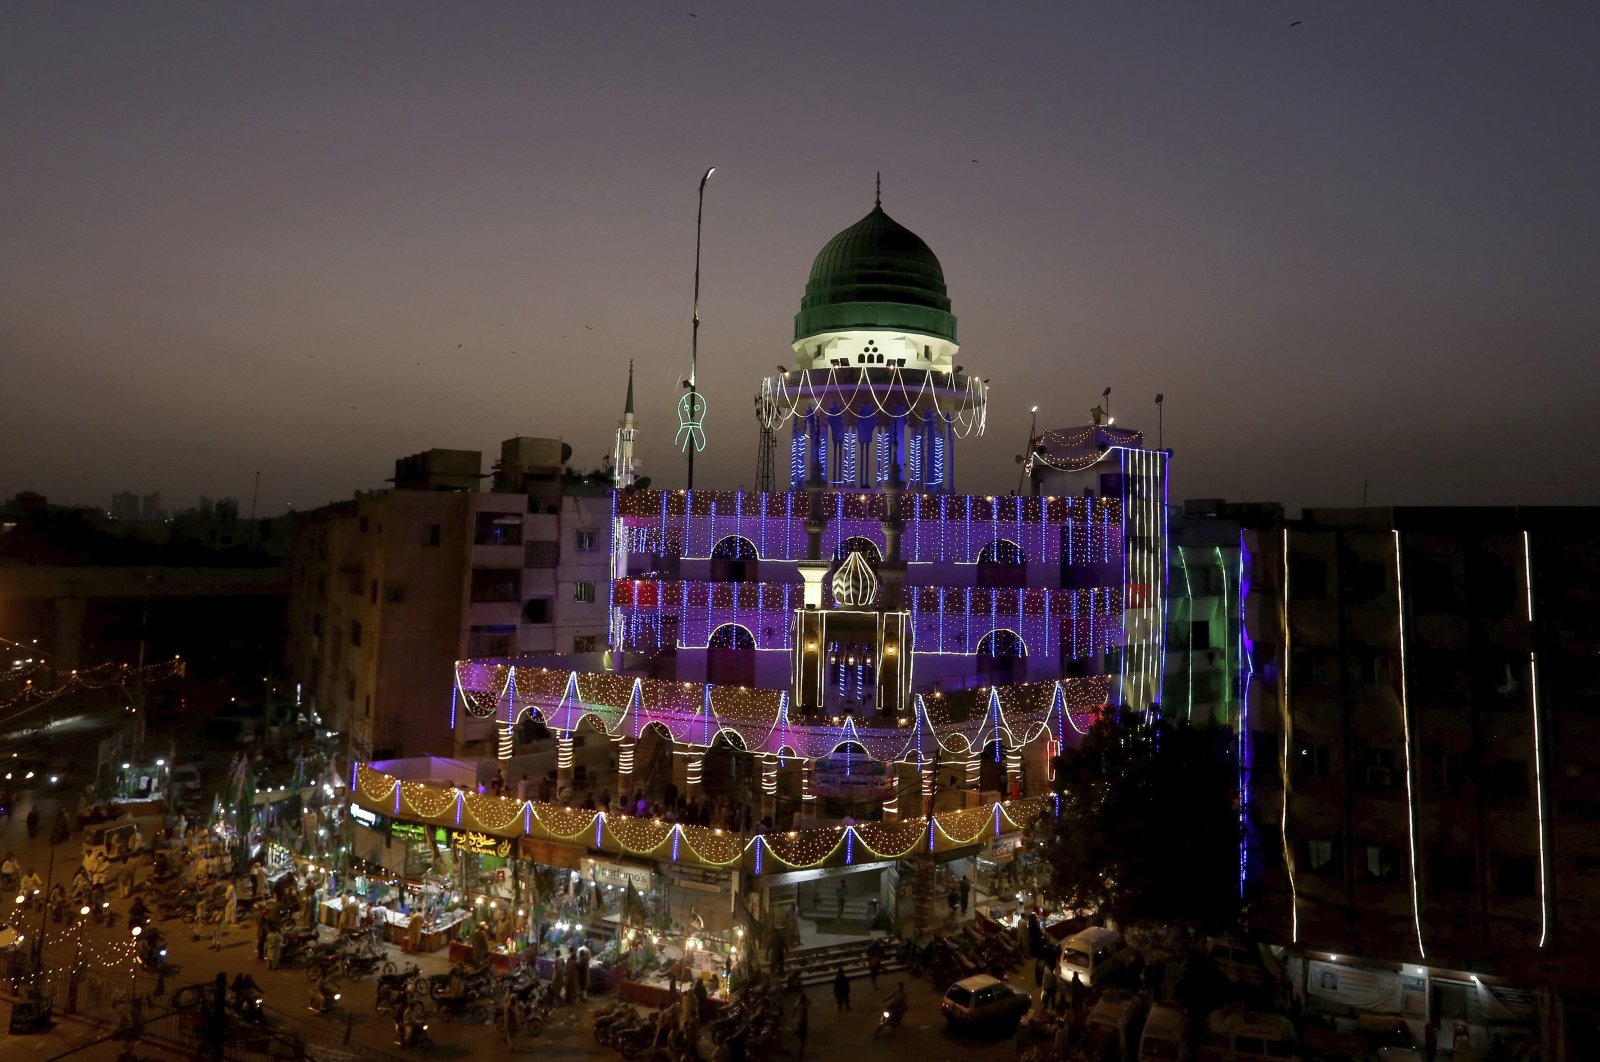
[0,0,1600,515]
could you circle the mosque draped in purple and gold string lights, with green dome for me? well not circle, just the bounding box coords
[352,188,1170,953]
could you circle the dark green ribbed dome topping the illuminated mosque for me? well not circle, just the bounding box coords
[795,206,955,342]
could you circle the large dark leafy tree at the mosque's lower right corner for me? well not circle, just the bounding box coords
[1042,712,1238,926]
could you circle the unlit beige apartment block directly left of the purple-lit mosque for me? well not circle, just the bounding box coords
[288,438,611,760]
